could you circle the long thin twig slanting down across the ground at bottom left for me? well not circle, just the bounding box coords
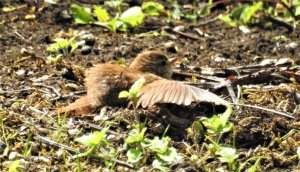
[34,135,135,169]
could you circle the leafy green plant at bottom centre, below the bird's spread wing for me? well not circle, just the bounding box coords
[125,124,181,171]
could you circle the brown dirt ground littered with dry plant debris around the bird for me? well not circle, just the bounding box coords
[0,0,300,171]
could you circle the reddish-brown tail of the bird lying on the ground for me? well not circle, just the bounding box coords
[54,96,93,116]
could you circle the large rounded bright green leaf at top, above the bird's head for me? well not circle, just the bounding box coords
[120,7,144,27]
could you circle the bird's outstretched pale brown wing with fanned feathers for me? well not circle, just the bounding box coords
[137,79,229,108]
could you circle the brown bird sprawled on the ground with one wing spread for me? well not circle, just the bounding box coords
[57,51,229,115]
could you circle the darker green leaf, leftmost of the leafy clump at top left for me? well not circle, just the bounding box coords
[70,4,95,24]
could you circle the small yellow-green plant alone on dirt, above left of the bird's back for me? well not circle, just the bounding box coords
[47,38,78,62]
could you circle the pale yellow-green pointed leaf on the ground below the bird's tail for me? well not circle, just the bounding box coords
[75,127,108,147]
